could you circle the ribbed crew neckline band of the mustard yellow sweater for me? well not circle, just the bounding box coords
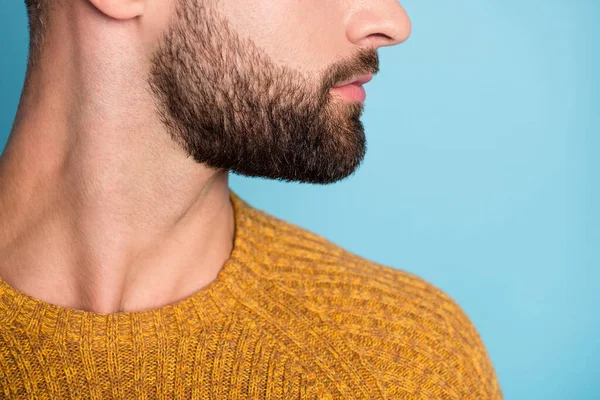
[0,189,252,339]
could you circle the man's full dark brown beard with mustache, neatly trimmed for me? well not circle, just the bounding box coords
[148,0,379,184]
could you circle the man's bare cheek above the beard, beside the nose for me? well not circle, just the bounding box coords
[219,0,349,72]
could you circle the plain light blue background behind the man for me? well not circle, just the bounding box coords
[0,0,600,400]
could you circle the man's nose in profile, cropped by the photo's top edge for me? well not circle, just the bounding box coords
[348,0,412,48]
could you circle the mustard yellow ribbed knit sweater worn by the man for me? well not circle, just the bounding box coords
[0,192,502,400]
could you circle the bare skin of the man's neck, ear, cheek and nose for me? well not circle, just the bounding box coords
[0,0,410,313]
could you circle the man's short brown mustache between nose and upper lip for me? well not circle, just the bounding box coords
[322,47,379,90]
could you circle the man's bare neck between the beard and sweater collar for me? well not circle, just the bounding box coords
[0,31,234,313]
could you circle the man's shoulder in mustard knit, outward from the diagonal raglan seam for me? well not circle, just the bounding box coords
[246,205,502,399]
